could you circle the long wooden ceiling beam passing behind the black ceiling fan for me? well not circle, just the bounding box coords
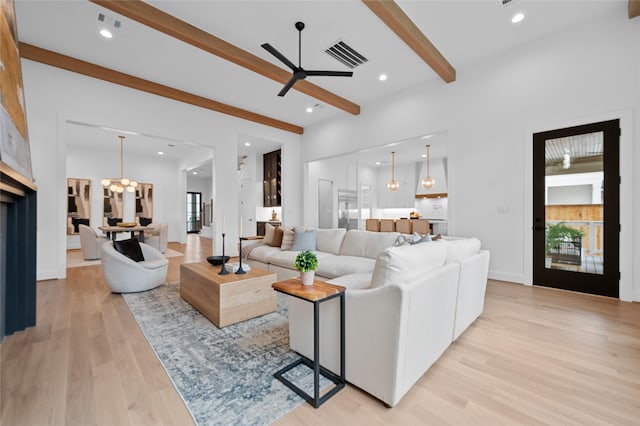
[90,0,360,115]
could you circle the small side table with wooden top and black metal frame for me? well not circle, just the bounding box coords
[271,278,346,408]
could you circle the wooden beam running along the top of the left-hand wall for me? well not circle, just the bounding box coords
[20,43,304,135]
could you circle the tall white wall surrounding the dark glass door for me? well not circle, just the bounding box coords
[303,11,640,300]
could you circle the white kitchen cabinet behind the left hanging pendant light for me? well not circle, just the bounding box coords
[377,163,417,209]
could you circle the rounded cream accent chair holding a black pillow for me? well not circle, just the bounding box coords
[102,243,169,293]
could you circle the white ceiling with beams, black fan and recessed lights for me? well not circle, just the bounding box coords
[16,0,635,133]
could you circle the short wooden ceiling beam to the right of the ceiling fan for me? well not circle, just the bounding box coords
[362,0,456,83]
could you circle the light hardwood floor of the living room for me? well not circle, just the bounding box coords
[0,235,640,426]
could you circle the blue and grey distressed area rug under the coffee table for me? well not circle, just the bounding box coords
[123,284,331,425]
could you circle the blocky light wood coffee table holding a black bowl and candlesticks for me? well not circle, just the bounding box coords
[180,261,277,328]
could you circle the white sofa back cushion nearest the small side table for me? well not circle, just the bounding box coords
[371,243,447,288]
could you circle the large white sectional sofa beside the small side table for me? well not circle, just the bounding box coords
[249,230,489,406]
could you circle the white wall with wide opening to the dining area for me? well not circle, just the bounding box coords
[22,60,302,280]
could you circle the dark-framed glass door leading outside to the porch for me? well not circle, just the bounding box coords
[533,120,620,297]
